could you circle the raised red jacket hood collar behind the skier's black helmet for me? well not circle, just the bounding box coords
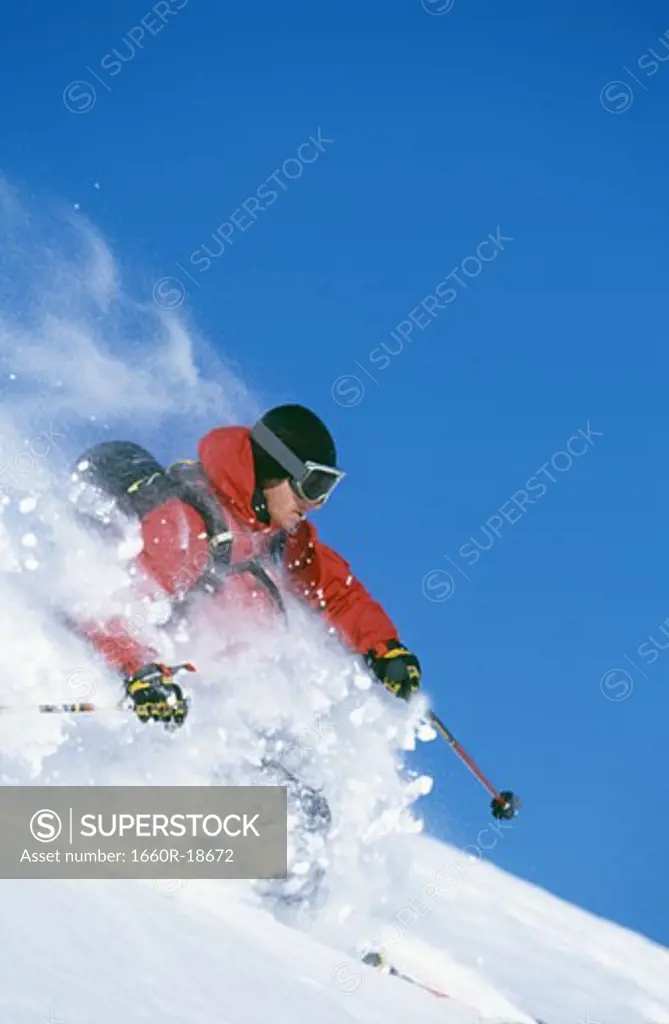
[198,427,267,529]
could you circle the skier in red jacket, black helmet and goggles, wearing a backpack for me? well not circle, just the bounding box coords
[75,404,421,729]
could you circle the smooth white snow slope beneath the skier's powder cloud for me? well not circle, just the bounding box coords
[0,837,669,1024]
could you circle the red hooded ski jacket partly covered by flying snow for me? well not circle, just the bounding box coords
[83,427,398,675]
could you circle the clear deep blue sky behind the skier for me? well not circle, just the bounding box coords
[0,0,669,943]
